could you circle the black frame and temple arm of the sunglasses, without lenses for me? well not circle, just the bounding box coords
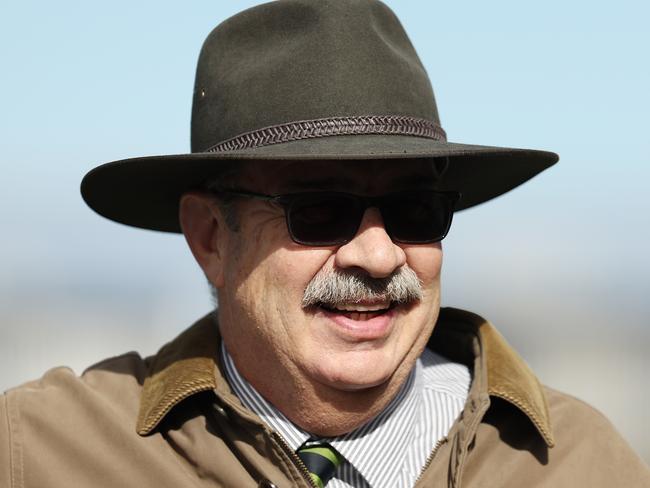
[214,189,461,247]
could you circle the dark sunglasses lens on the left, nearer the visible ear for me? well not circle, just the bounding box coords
[287,193,363,246]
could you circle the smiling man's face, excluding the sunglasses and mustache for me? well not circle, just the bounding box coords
[213,161,442,391]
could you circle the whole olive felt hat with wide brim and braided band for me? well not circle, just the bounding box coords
[81,0,558,232]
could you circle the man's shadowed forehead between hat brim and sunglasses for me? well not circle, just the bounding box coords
[242,159,437,194]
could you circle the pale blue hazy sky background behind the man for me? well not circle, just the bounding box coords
[0,0,650,456]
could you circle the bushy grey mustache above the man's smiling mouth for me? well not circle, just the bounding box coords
[302,266,422,307]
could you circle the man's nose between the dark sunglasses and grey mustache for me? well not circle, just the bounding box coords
[335,208,406,278]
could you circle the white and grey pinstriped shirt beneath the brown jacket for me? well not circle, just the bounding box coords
[221,342,471,488]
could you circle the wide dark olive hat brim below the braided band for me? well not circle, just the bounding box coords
[81,135,559,232]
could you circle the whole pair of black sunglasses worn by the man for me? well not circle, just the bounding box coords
[218,190,460,246]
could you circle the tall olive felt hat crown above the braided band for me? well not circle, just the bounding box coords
[192,0,440,152]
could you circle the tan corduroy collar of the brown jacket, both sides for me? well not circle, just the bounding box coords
[136,308,554,447]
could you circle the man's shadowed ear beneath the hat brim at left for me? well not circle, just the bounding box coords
[178,192,227,288]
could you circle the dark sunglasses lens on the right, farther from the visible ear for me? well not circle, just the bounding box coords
[381,191,455,244]
